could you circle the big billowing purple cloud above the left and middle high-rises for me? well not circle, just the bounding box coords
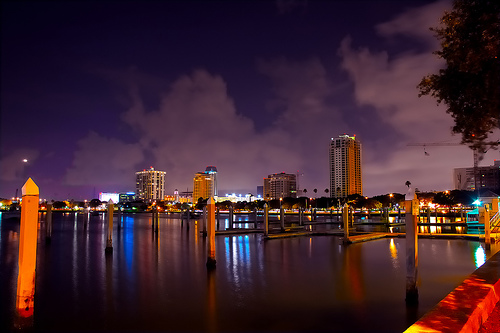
[119,70,300,191]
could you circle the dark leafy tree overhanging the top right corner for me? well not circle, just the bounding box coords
[418,0,500,152]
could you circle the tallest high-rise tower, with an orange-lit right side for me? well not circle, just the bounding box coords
[330,135,363,198]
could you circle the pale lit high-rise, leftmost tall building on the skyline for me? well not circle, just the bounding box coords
[135,167,166,201]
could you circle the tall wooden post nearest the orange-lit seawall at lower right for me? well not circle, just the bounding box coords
[405,194,420,304]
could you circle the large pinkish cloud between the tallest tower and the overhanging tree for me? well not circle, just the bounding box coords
[339,1,472,194]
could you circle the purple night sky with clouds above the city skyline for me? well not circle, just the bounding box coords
[0,0,498,200]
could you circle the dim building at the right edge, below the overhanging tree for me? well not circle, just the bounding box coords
[453,161,500,191]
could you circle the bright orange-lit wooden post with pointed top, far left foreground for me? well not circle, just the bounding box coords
[15,178,40,328]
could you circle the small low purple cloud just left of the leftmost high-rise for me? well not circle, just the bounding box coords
[65,132,144,190]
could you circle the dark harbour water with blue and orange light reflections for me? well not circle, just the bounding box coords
[0,213,498,332]
